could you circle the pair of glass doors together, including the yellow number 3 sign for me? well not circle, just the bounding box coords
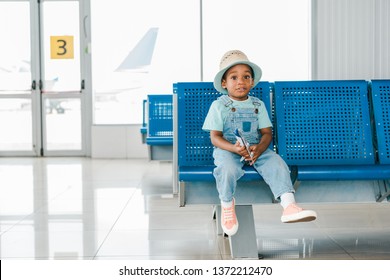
[0,0,88,156]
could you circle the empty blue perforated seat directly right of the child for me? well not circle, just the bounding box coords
[274,80,390,201]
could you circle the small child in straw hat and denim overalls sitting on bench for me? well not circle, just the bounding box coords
[202,50,317,236]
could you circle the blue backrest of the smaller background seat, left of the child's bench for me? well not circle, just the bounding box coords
[148,94,173,137]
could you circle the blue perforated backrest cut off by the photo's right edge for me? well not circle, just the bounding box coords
[371,80,390,164]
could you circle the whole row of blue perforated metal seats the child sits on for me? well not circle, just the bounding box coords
[173,80,390,258]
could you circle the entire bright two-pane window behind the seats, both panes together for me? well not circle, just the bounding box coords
[91,0,310,124]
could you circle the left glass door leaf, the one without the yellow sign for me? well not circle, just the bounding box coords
[0,1,38,155]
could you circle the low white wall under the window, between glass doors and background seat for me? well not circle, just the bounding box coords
[91,125,148,158]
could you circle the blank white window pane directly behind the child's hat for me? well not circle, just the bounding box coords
[203,0,310,81]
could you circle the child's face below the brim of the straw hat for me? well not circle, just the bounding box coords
[222,64,254,101]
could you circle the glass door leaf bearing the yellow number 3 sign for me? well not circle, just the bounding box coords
[40,1,85,155]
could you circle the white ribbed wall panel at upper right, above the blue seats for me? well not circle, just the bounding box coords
[312,0,390,80]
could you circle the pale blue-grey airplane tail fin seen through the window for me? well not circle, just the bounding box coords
[115,28,158,71]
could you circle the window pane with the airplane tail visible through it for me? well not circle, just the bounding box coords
[91,0,200,124]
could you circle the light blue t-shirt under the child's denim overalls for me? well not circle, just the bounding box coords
[202,95,272,131]
